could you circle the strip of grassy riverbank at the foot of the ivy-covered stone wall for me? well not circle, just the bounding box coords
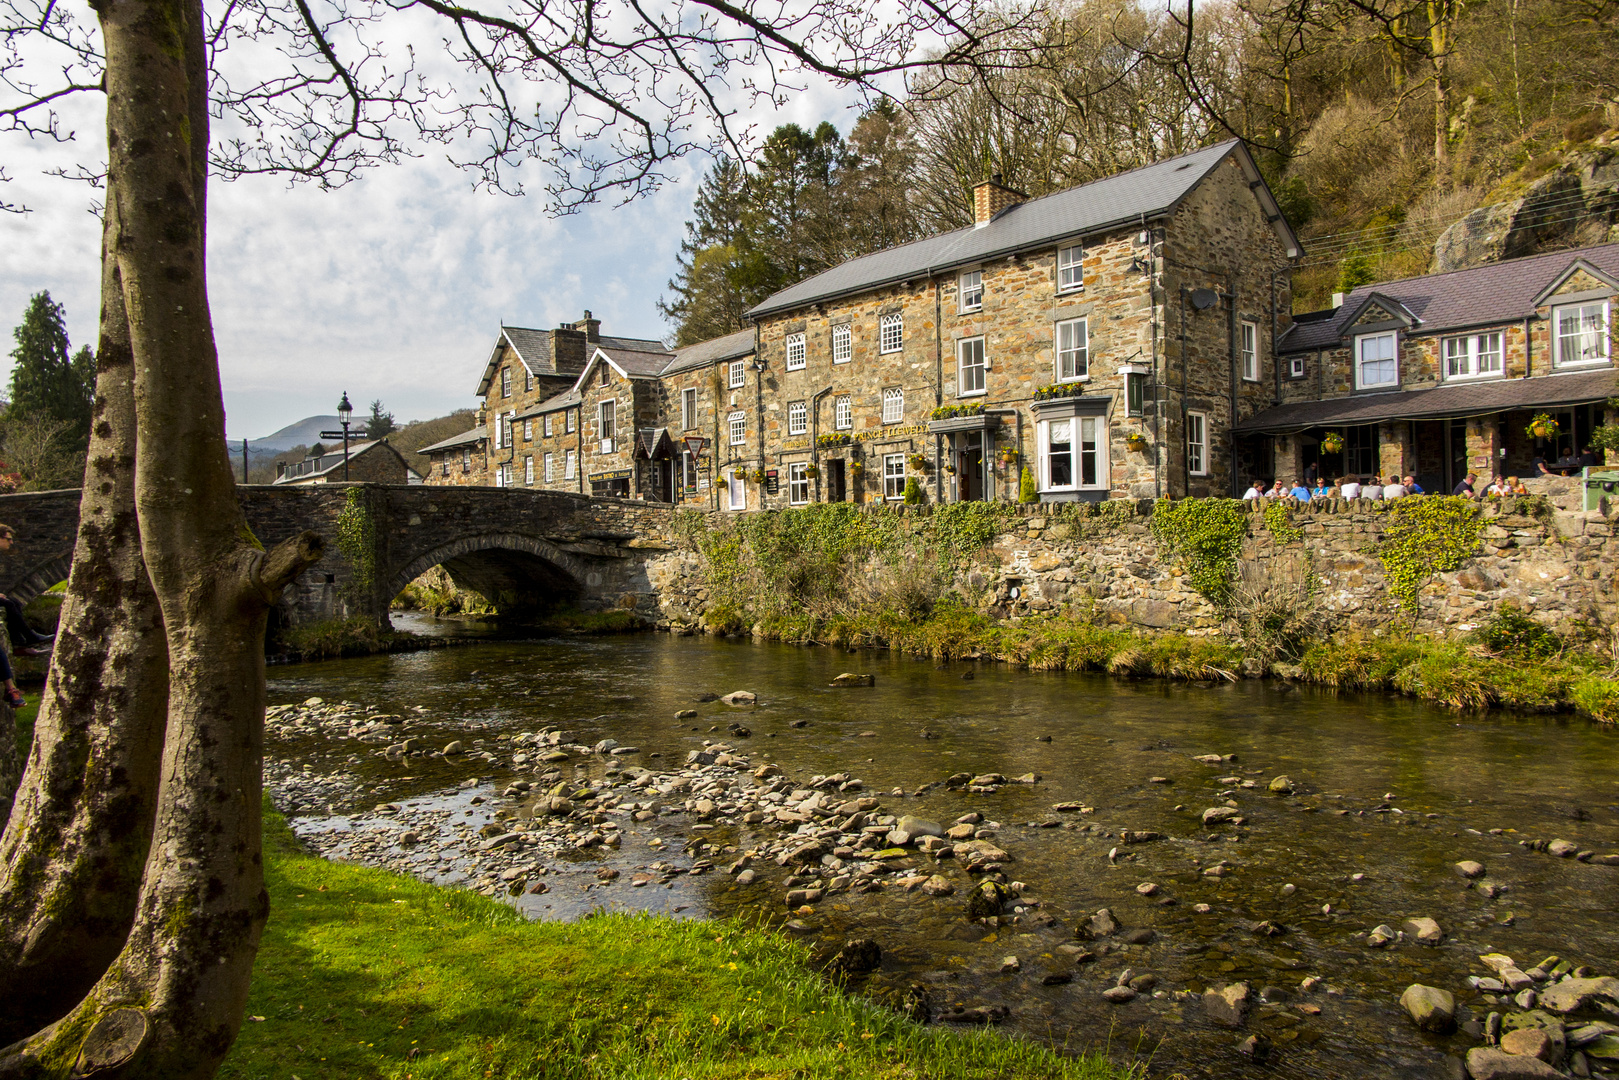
[744,599,1619,724]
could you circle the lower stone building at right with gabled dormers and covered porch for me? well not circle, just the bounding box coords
[1237,244,1619,492]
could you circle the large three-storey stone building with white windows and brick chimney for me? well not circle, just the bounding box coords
[741,139,1300,508]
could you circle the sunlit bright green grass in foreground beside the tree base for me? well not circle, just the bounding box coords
[219,806,1128,1080]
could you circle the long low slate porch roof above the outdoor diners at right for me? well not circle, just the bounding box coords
[1237,369,1619,434]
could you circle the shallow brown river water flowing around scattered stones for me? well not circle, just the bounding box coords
[269,635,1619,1078]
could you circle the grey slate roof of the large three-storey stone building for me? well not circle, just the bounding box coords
[748,139,1303,319]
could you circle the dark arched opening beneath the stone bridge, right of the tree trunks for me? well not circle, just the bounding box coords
[387,533,588,606]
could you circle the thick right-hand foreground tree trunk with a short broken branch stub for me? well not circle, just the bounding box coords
[0,0,321,1080]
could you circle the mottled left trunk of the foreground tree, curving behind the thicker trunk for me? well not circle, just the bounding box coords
[0,179,168,1044]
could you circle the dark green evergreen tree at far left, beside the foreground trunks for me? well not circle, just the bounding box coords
[8,291,96,452]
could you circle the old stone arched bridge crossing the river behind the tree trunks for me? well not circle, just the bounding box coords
[0,484,674,625]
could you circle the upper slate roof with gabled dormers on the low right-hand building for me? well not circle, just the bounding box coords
[1276,243,1619,353]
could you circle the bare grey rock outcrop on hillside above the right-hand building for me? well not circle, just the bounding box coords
[1433,146,1619,274]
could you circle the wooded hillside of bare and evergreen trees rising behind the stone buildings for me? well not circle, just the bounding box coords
[661,0,1619,335]
